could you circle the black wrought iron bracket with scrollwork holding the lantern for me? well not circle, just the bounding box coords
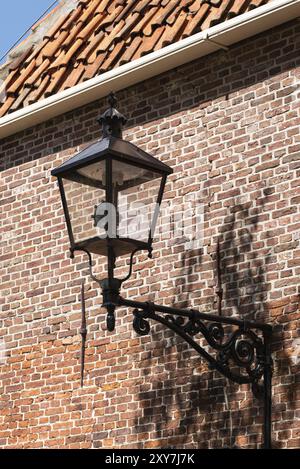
[117,297,272,449]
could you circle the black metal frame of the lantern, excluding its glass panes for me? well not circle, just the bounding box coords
[52,94,173,331]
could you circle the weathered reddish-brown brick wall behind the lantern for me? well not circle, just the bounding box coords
[0,21,300,448]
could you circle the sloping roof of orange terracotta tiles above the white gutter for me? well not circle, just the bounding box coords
[0,0,272,117]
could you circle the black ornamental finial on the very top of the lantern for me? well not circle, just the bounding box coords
[98,92,127,138]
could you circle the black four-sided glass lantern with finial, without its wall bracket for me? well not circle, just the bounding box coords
[52,94,173,330]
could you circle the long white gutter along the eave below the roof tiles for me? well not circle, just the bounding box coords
[0,0,300,138]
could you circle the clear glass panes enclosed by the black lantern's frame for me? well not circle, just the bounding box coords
[64,159,162,255]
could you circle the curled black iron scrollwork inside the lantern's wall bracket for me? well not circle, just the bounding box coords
[133,308,264,384]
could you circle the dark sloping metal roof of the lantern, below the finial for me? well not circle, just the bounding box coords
[51,136,173,177]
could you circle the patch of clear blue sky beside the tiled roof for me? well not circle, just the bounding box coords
[0,0,54,59]
